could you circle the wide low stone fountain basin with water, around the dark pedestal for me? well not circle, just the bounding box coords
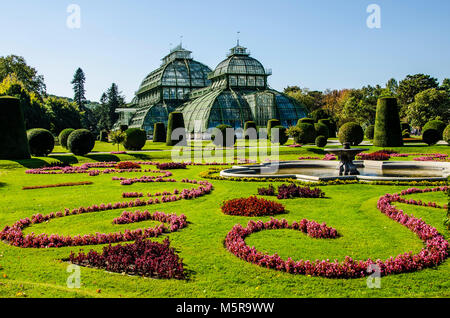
[220,160,450,182]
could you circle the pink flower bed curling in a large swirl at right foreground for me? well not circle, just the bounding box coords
[225,187,449,278]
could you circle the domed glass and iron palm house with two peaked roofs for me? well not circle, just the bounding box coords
[116,43,308,134]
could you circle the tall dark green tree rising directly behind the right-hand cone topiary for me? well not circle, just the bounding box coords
[397,74,439,116]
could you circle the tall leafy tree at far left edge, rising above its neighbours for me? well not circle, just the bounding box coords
[0,55,46,97]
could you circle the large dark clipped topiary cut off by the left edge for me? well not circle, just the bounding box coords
[0,96,30,159]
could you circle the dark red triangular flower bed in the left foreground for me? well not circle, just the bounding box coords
[69,239,185,279]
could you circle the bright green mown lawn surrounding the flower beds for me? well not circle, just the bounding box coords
[0,143,450,297]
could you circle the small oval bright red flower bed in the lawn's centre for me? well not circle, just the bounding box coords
[222,197,285,216]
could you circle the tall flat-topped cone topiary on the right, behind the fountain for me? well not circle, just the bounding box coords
[373,97,403,147]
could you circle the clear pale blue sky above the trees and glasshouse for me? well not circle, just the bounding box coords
[0,0,450,101]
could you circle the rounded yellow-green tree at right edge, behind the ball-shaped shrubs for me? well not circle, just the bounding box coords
[406,88,450,127]
